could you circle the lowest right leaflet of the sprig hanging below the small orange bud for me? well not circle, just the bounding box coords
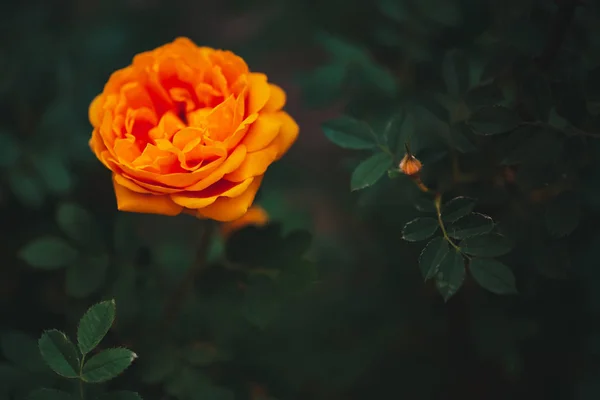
[469,258,517,294]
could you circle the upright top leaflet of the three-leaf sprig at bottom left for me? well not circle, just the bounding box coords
[77,300,116,354]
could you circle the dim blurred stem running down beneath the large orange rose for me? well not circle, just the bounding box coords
[163,221,216,329]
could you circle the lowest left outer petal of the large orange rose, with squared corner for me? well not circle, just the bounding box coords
[114,175,183,216]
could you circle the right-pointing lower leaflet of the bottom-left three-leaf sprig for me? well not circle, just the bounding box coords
[81,348,137,383]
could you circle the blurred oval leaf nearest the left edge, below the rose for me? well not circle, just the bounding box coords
[19,236,77,269]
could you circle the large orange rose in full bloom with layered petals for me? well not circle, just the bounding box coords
[89,38,298,221]
